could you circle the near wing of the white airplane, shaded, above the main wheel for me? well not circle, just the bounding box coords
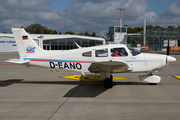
[88,61,132,73]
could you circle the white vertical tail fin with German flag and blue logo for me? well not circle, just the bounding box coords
[12,28,45,59]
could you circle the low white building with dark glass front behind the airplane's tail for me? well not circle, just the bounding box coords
[0,33,105,52]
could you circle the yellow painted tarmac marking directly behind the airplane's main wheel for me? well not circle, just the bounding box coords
[62,75,128,81]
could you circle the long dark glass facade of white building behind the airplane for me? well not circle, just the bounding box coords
[43,38,103,50]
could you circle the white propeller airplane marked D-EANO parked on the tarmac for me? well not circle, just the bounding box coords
[6,28,176,88]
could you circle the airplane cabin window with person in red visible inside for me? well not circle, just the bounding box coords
[111,47,128,57]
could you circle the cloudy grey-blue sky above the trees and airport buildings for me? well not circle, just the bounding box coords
[0,0,180,33]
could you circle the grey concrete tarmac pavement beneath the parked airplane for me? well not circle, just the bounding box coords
[0,53,180,120]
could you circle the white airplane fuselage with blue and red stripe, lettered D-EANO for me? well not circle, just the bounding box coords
[24,44,174,72]
